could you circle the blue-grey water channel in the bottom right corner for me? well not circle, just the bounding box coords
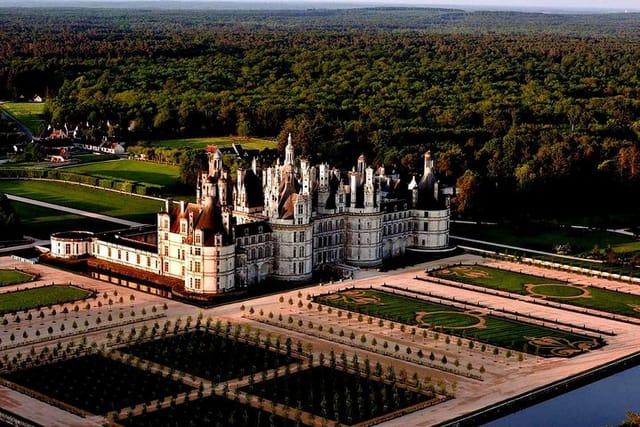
[484,366,640,427]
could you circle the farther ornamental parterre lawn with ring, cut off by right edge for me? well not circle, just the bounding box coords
[429,265,640,318]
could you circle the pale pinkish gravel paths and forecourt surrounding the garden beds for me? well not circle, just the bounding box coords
[0,255,640,426]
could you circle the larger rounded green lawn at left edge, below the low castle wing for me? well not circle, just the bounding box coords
[0,285,91,313]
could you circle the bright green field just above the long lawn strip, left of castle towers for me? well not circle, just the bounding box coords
[65,160,180,186]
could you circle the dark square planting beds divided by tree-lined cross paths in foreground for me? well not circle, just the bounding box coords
[0,316,444,426]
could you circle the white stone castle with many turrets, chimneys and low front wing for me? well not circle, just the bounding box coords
[51,135,450,295]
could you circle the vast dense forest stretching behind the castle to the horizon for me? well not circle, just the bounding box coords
[0,8,640,226]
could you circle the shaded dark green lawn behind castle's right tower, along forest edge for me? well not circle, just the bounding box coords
[451,223,640,254]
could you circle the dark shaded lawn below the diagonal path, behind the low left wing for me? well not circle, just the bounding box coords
[11,202,123,239]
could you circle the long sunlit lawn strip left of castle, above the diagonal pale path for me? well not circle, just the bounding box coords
[0,180,164,224]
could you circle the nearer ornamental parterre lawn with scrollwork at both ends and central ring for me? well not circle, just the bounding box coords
[316,289,603,357]
